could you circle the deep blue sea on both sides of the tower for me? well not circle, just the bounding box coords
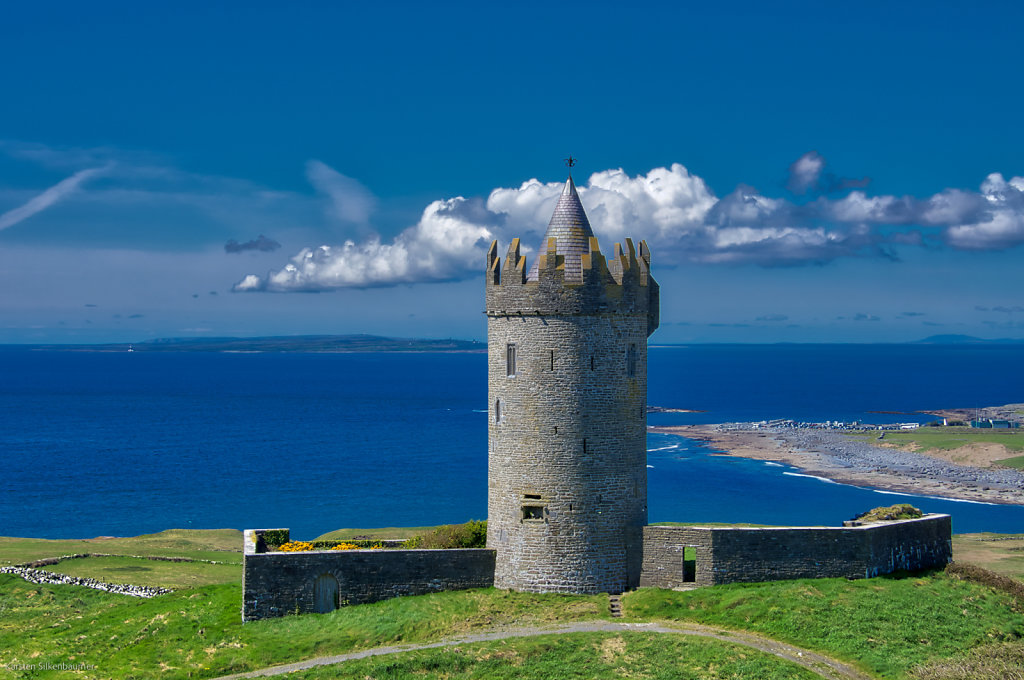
[0,345,1024,539]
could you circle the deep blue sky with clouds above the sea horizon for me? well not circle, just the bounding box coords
[0,2,1024,343]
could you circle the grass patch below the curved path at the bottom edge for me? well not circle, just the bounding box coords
[288,633,819,680]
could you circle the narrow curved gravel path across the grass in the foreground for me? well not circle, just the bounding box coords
[214,621,871,680]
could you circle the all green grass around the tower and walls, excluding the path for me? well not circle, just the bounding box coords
[0,529,1024,680]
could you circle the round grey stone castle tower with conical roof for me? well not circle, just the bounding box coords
[485,176,658,593]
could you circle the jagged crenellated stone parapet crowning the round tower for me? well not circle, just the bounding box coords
[484,237,659,335]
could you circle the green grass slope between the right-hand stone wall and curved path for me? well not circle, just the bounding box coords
[623,572,1024,678]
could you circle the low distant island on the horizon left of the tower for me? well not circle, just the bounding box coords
[17,335,487,352]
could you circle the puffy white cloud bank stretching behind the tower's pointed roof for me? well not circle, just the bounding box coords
[234,152,1024,291]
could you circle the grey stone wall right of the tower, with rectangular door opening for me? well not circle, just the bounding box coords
[640,515,952,588]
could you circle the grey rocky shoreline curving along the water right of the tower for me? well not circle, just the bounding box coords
[649,423,1024,505]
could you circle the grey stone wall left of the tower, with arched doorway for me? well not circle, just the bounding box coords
[242,529,495,622]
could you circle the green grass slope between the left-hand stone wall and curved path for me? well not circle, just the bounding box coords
[0,575,608,679]
